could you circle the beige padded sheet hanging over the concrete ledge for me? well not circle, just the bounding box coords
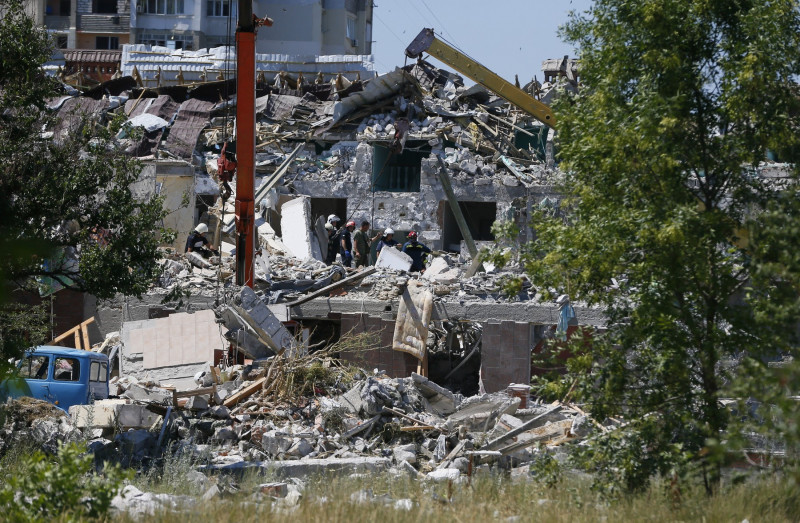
[392,281,433,360]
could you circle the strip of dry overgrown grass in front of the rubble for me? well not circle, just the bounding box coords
[118,475,800,523]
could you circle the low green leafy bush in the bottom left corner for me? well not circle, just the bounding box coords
[0,443,129,521]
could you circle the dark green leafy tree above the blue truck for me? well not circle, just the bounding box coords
[0,0,166,361]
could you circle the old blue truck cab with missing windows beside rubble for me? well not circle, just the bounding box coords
[0,345,109,411]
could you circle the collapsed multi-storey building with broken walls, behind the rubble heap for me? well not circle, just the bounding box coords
[36,46,602,400]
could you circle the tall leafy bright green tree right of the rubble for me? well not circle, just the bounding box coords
[494,0,800,492]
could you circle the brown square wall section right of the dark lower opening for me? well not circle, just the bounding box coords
[481,321,533,392]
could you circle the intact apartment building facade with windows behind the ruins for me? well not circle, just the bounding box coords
[28,0,373,52]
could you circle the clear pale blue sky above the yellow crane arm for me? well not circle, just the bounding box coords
[372,0,591,85]
